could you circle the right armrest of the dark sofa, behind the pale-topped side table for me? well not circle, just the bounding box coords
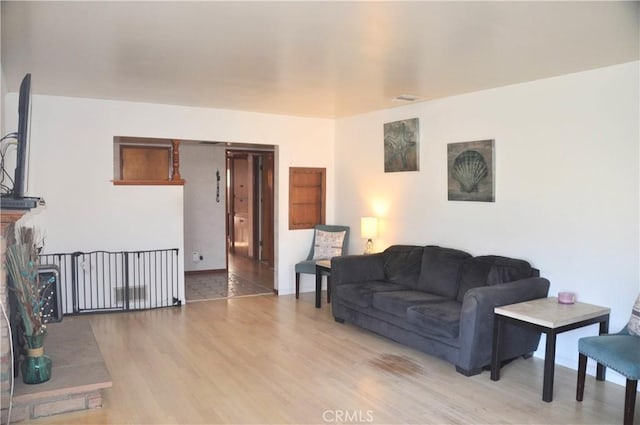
[458,277,550,371]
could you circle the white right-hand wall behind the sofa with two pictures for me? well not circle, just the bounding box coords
[335,62,640,384]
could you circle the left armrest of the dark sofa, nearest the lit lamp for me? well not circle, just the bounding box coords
[331,253,384,286]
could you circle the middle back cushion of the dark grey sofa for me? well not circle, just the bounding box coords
[416,246,471,298]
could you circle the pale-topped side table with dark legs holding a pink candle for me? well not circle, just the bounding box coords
[491,297,611,402]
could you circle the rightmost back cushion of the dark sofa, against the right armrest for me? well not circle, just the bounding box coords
[456,255,535,301]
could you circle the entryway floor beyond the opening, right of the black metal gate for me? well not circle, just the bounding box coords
[185,254,273,302]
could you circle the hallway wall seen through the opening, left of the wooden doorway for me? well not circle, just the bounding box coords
[180,143,227,271]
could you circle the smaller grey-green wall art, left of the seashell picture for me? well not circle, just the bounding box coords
[384,118,419,173]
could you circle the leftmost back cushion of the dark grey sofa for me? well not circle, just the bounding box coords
[383,245,423,287]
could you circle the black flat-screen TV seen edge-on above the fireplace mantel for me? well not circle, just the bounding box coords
[11,74,31,198]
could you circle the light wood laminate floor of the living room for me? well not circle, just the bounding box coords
[22,293,640,424]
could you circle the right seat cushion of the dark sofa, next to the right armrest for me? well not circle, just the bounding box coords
[407,301,462,338]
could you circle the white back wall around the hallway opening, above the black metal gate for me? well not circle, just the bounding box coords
[5,94,335,295]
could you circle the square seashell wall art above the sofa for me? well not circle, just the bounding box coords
[447,140,495,202]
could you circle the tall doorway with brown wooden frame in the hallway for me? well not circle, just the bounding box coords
[226,149,274,289]
